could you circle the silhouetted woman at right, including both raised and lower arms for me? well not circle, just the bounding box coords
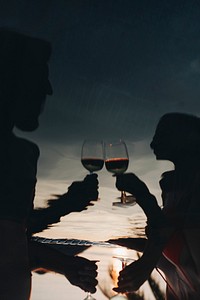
[113,113,200,300]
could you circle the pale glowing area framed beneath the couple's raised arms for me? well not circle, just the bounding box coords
[36,190,146,241]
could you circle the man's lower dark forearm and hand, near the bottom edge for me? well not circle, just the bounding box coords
[29,241,98,293]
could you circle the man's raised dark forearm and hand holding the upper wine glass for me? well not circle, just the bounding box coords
[27,174,98,236]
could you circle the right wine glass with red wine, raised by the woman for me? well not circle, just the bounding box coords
[105,140,136,206]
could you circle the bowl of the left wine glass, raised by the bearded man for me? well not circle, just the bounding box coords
[81,140,104,174]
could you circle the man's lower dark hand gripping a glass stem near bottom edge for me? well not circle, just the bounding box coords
[64,256,98,293]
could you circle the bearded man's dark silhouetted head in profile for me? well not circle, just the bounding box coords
[0,29,52,131]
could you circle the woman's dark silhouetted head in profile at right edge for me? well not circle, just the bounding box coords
[150,112,200,163]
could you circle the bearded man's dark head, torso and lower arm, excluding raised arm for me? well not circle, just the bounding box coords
[0,29,98,300]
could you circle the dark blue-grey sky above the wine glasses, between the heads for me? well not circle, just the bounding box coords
[0,0,200,178]
